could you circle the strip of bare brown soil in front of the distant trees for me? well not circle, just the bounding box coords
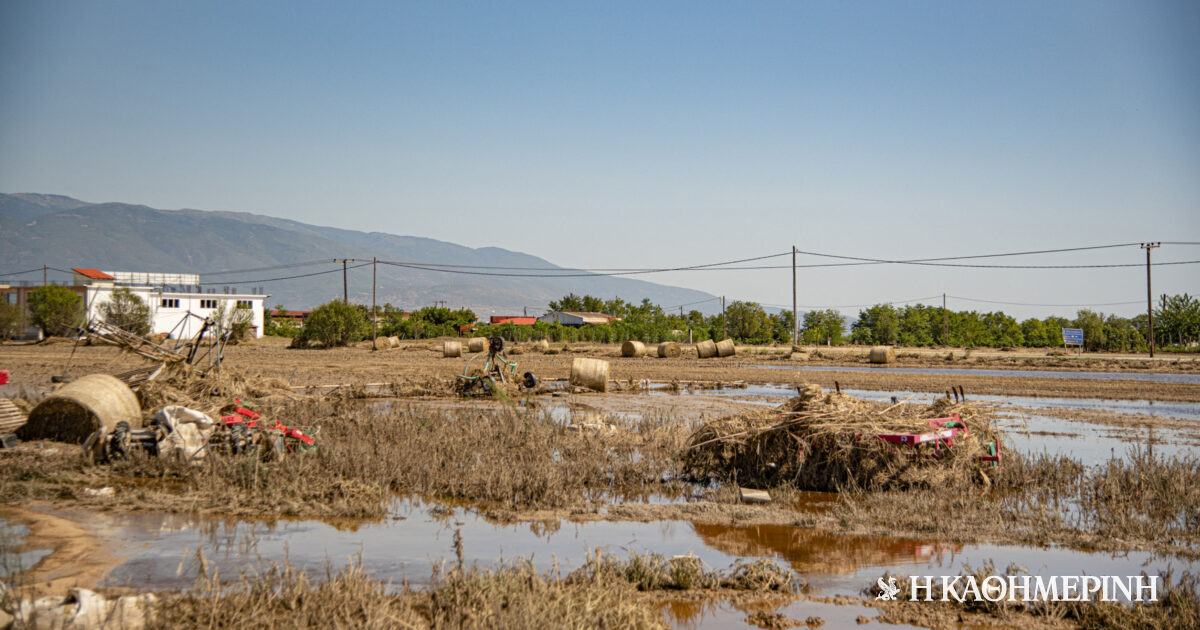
[7,337,1200,402]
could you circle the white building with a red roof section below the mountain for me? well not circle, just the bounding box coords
[71,269,269,338]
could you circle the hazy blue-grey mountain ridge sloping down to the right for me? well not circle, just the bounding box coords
[0,193,713,309]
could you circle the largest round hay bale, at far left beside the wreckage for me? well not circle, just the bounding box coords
[20,374,142,444]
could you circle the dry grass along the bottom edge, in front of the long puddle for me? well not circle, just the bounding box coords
[149,552,803,629]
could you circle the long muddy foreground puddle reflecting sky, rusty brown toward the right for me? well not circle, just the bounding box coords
[16,499,1180,612]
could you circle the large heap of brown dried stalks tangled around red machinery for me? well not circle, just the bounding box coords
[684,385,1004,491]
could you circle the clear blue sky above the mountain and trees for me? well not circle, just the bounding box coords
[0,0,1200,316]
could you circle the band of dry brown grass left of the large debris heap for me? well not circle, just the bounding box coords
[0,401,685,517]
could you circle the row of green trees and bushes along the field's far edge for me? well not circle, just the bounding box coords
[268,293,1200,350]
